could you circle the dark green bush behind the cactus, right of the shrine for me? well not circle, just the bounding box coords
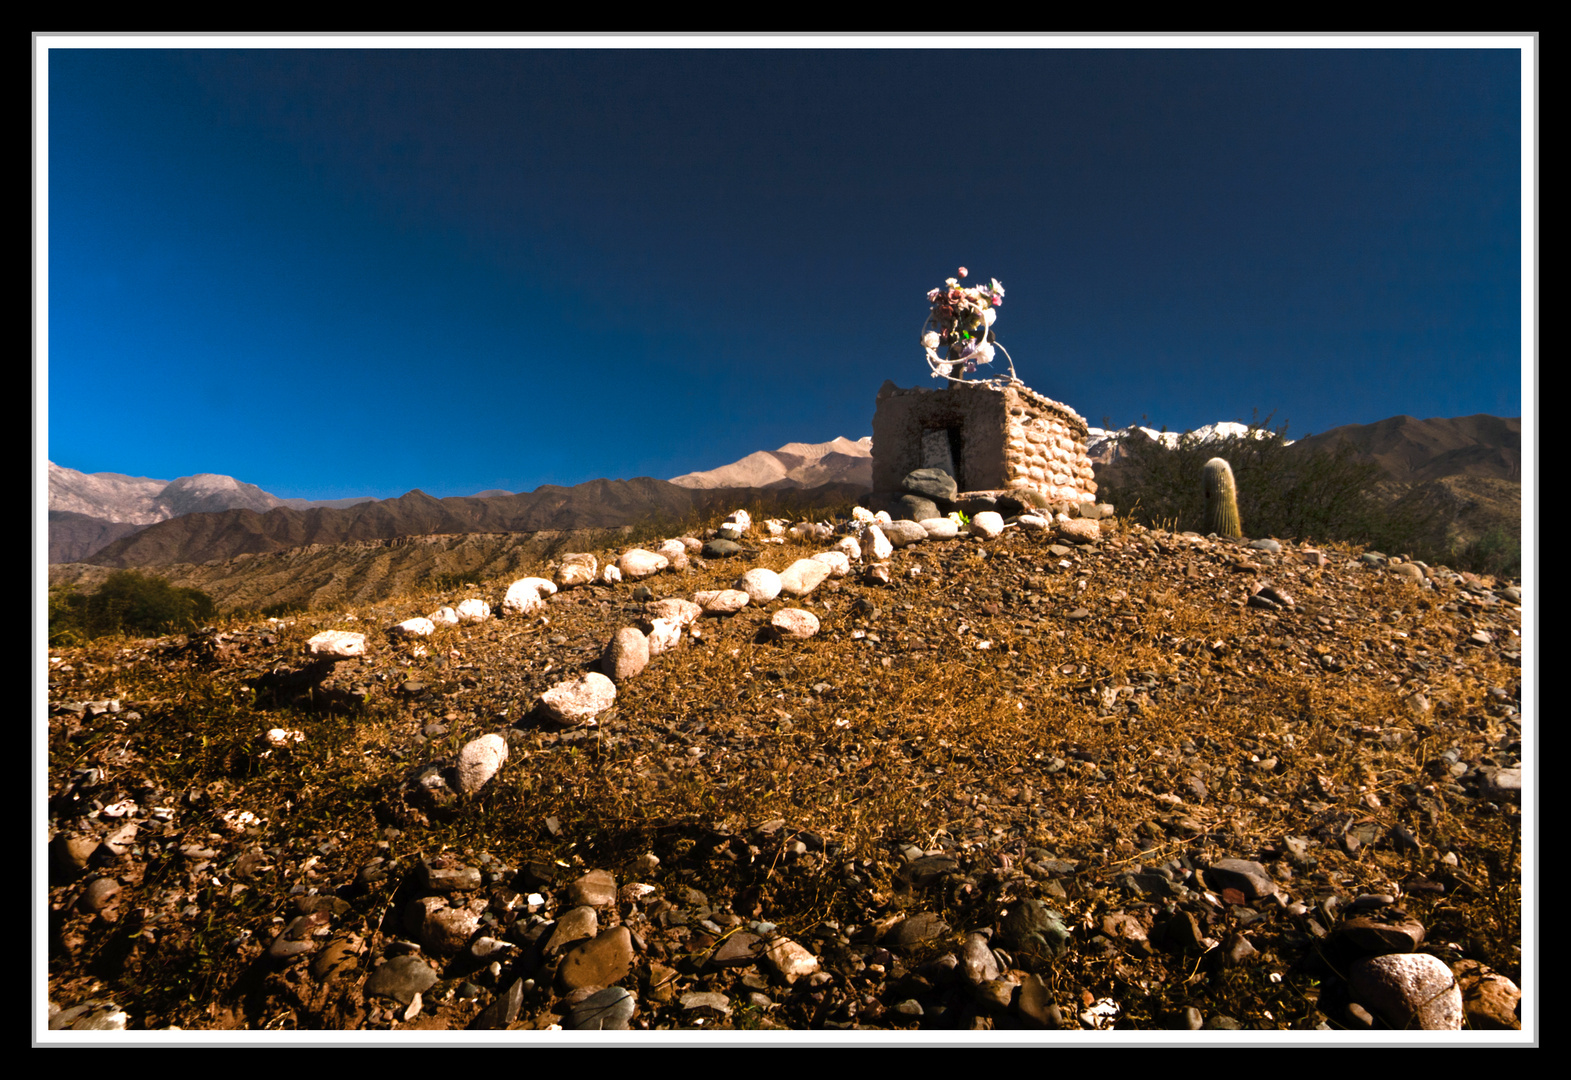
[1104,418,1433,555]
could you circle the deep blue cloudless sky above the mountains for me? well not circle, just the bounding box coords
[35,38,1536,498]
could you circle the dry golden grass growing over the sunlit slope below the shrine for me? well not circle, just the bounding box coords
[50,520,1521,1027]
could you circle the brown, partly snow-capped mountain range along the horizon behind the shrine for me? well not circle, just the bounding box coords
[49,415,1522,616]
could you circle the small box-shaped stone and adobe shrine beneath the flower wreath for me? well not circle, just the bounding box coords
[873,380,1097,503]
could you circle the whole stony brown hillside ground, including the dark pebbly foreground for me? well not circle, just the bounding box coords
[47,520,1530,1038]
